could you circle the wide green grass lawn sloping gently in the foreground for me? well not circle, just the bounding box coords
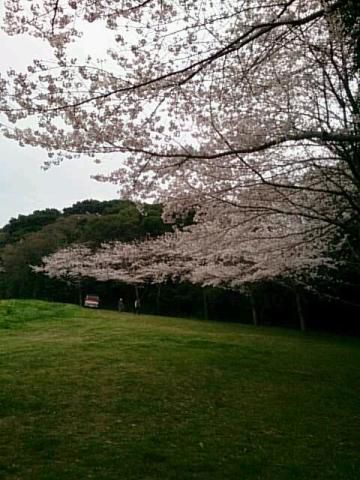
[0,301,360,480]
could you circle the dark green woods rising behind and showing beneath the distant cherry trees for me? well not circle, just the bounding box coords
[0,200,360,334]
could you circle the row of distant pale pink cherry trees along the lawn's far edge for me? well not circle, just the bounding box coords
[36,198,334,329]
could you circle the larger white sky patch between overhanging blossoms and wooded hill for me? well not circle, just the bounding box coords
[0,138,118,227]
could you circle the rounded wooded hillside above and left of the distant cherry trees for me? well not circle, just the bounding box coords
[0,200,171,301]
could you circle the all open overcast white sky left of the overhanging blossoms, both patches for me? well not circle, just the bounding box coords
[0,0,118,227]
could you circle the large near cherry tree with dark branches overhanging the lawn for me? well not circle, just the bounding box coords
[0,0,360,286]
